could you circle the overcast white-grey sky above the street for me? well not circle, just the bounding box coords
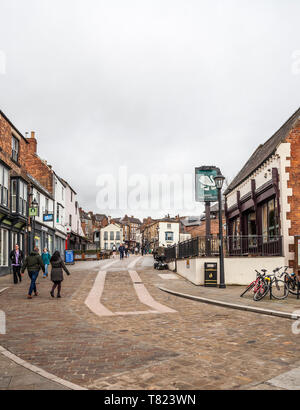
[0,0,300,217]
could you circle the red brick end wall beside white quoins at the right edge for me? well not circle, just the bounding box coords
[286,120,300,266]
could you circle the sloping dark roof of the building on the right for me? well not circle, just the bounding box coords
[225,108,300,195]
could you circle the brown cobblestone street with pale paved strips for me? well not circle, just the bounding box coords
[0,256,300,390]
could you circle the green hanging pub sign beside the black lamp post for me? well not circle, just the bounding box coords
[195,166,220,202]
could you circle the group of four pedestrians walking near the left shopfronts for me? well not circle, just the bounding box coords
[10,245,70,299]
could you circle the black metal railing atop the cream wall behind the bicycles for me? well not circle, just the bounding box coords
[166,235,282,260]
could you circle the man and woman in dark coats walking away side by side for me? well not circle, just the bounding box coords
[21,248,70,299]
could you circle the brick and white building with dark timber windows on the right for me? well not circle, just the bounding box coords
[225,105,300,266]
